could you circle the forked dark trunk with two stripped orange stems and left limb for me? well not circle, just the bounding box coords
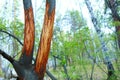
[0,0,55,80]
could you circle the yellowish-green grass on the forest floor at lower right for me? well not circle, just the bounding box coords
[47,62,120,80]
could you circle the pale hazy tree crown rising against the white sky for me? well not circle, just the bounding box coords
[64,10,86,32]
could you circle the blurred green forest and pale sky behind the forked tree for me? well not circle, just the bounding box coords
[0,0,120,80]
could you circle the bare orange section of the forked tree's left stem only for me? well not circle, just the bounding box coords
[22,7,35,56]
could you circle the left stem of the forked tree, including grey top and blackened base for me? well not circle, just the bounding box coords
[20,0,35,65]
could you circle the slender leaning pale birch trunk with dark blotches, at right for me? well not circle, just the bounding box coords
[85,0,114,78]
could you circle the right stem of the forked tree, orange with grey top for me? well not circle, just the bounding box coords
[35,0,55,80]
